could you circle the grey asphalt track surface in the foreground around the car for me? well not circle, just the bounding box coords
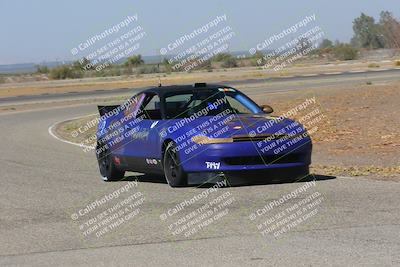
[0,71,400,266]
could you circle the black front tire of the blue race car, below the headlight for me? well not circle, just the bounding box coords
[163,142,188,187]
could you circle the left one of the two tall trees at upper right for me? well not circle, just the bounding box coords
[352,13,384,49]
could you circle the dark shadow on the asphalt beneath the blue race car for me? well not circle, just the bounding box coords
[122,174,336,188]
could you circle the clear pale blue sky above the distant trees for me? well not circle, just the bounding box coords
[0,0,400,64]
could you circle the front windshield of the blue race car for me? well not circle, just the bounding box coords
[165,88,262,119]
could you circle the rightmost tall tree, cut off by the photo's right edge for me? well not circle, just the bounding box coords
[379,11,400,48]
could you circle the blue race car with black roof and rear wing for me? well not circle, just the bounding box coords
[96,83,312,187]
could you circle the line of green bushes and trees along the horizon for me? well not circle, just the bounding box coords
[37,11,400,79]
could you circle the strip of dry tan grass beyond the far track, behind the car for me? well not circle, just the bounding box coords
[0,62,393,98]
